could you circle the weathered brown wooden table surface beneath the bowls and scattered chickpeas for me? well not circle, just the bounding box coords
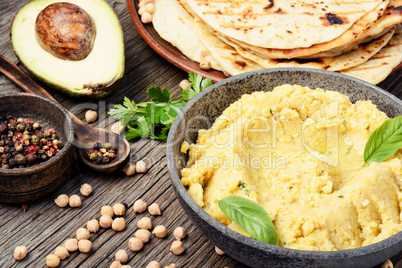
[0,0,402,268]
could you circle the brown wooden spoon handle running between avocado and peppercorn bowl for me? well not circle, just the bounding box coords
[0,55,89,135]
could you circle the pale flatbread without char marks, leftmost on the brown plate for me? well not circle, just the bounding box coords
[152,0,222,71]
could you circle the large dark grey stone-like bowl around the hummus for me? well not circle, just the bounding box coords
[167,68,402,268]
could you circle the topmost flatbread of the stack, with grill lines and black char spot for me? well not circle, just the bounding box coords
[188,0,383,49]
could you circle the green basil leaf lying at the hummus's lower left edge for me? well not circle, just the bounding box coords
[218,196,279,245]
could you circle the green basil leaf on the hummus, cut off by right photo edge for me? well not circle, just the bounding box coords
[363,116,402,167]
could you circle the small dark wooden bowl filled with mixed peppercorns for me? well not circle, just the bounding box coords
[0,93,74,203]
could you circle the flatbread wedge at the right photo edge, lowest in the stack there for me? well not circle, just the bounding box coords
[340,25,402,85]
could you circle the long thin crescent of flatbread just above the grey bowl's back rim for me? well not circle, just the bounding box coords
[226,28,394,71]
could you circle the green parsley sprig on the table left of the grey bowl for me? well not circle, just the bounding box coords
[108,73,212,141]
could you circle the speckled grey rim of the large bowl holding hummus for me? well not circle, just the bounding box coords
[166,67,402,260]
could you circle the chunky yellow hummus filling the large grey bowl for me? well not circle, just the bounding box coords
[181,85,402,251]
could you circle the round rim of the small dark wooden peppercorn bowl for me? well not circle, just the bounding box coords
[0,93,74,176]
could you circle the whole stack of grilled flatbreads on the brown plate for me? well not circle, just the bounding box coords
[152,0,402,84]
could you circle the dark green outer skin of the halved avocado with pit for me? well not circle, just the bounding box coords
[9,0,125,100]
